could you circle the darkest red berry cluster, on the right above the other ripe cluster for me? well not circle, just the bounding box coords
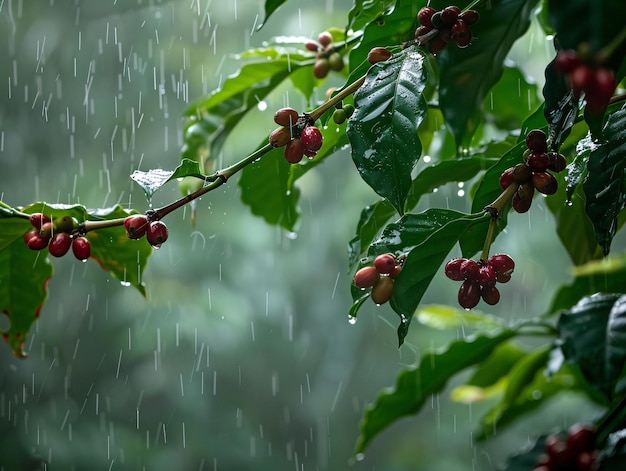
[500,129,567,213]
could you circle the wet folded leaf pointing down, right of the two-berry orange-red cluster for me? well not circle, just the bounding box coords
[388,209,490,345]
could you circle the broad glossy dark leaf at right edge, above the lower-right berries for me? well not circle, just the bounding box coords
[558,294,626,398]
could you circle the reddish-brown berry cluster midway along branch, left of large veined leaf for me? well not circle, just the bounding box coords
[269,108,324,164]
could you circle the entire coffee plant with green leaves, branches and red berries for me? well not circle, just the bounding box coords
[0,0,626,471]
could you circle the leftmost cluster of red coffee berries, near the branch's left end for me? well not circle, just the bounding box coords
[24,213,91,260]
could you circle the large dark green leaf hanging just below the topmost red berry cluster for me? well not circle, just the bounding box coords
[437,0,537,147]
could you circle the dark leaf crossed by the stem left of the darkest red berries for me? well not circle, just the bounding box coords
[460,142,526,257]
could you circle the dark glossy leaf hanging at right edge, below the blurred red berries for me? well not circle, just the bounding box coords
[583,108,626,255]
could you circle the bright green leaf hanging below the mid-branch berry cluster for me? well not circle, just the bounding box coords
[238,145,300,231]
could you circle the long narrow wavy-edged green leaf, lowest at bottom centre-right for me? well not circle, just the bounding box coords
[356,329,515,453]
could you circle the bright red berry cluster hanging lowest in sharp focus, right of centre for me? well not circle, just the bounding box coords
[445,253,515,309]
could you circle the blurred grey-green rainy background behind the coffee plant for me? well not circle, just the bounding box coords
[0,0,608,471]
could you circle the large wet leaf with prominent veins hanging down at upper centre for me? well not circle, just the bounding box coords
[347,48,427,214]
